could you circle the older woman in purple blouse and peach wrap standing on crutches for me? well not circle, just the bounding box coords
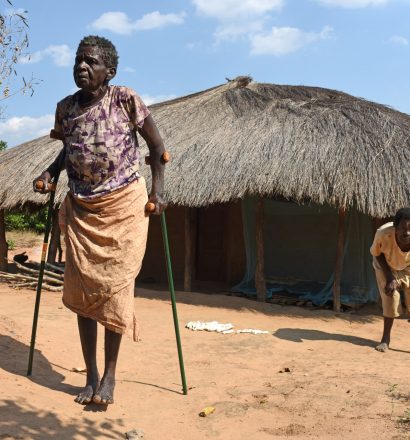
[36,36,166,404]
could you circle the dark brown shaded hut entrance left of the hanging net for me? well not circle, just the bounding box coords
[138,201,246,291]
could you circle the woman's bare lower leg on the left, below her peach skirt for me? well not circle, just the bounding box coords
[75,315,100,404]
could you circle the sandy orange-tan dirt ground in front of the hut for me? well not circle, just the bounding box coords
[0,242,410,440]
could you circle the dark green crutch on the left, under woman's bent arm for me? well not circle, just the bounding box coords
[27,130,64,376]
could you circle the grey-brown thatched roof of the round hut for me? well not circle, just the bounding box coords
[0,77,410,217]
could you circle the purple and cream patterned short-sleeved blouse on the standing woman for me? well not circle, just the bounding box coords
[54,86,150,199]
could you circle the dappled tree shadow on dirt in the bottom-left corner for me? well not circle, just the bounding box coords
[0,398,125,440]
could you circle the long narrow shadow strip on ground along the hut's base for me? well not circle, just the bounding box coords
[135,284,379,323]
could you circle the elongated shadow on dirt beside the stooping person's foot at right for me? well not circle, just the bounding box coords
[273,328,376,348]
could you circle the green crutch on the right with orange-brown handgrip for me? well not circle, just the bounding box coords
[145,151,188,395]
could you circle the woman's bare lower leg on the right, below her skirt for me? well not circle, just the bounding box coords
[93,329,122,404]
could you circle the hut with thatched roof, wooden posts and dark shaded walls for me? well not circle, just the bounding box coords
[0,77,410,309]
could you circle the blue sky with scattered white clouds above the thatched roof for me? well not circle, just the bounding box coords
[0,0,410,147]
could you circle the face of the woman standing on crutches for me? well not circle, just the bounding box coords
[73,46,113,92]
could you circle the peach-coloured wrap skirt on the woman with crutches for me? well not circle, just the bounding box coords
[59,177,149,341]
